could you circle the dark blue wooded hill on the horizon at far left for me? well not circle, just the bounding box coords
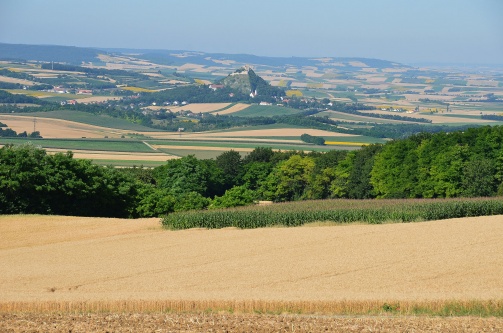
[0,43,104,65]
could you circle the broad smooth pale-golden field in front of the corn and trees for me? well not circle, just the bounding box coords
[0,216,503,304]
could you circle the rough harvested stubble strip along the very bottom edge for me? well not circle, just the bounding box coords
[0,313,503,333]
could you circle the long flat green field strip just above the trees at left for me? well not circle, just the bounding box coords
[0,138,154,153]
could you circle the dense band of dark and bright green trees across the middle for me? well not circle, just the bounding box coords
[0,126,503,217]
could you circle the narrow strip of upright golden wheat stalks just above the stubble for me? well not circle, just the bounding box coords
[0,300,503,317]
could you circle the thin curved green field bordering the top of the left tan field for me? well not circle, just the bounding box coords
[16,110,159,132]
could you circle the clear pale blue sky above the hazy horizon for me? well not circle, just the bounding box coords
[0,0,503,65]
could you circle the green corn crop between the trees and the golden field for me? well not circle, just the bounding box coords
[162,198,503,229]
